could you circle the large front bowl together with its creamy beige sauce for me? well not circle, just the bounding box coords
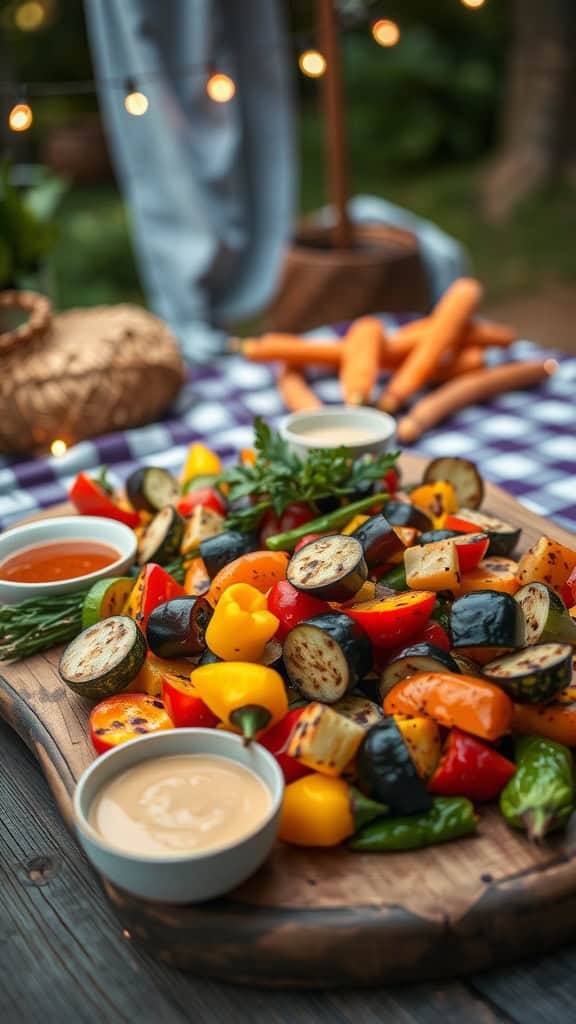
[74,729,284,903]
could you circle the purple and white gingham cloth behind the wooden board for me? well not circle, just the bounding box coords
[0,316,576,529]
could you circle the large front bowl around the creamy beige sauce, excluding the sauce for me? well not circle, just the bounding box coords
[74,729,284,903]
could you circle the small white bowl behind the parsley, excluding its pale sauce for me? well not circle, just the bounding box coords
[280,406,396,458]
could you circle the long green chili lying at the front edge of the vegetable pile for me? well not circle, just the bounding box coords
[349,797,478,853]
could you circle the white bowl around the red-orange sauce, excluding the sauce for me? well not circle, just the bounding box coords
[0,515,137,604]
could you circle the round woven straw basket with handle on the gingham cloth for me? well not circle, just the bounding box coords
[0,293,184,453]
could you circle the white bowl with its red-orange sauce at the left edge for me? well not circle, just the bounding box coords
[0,516,137,604]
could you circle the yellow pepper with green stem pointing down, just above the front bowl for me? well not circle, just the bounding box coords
[190,662,288,742]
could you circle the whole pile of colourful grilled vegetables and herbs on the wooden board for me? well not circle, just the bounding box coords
[5,422,576,852]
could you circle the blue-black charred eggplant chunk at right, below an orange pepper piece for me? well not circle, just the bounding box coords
[450,590,525,649]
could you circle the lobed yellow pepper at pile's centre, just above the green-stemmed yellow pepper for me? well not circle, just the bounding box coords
[206,583,280,662]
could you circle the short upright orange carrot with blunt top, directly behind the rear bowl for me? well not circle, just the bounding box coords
[340,316,385,406]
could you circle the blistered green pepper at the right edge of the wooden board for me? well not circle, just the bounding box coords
[500,735,574,839]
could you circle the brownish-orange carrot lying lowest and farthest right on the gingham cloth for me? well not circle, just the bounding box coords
[398,359,558,444]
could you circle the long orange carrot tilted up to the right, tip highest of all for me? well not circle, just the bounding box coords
[378,278,482,413]
